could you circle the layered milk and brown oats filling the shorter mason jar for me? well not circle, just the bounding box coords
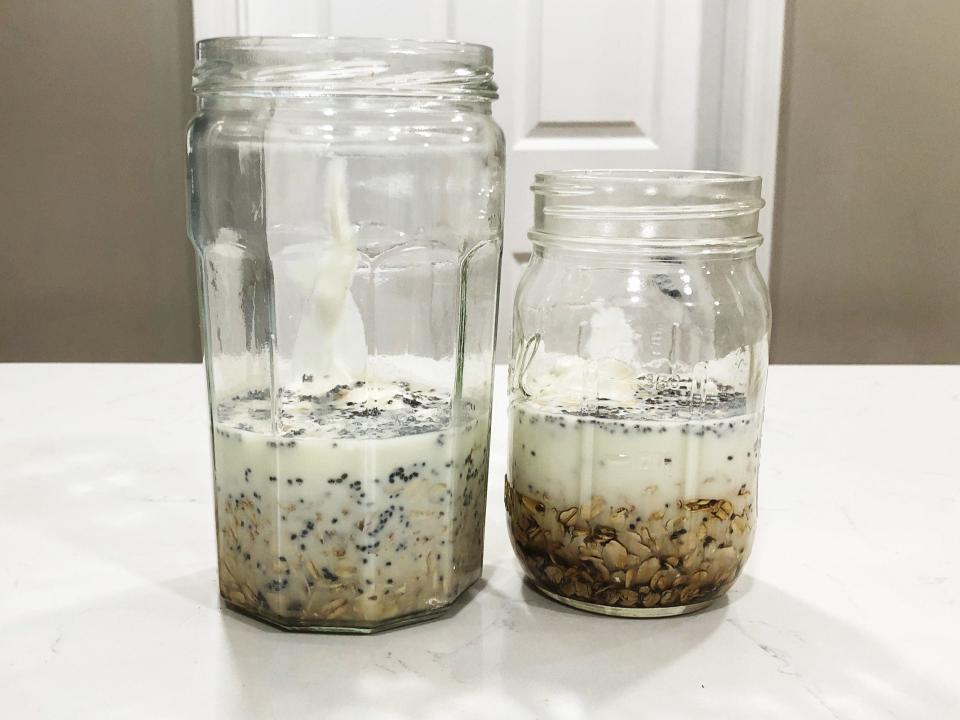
[505,366,761,615]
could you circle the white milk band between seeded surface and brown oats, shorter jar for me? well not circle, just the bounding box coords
[511,403,760,517]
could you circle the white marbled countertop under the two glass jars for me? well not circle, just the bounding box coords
[0,365,960,720]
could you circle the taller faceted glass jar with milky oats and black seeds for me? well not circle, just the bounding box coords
[187,37,504,632]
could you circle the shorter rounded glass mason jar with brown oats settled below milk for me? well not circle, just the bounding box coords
[505,170,770,617]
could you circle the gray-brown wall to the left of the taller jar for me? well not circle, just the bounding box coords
[0,0,200,361]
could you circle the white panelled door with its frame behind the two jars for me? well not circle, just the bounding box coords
[194,0,783,360]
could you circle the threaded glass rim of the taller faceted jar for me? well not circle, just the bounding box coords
[193,35,497,101]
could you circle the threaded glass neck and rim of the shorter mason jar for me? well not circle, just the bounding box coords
[530,169,764,247]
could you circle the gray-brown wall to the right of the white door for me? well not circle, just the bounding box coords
[771,0,960,363]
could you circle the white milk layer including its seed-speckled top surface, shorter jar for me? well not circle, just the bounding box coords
[510,346,761,513]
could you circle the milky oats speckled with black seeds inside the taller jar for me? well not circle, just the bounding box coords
[214,377,489,629]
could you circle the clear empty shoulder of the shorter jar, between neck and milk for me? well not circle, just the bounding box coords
[514,255,770,362]
